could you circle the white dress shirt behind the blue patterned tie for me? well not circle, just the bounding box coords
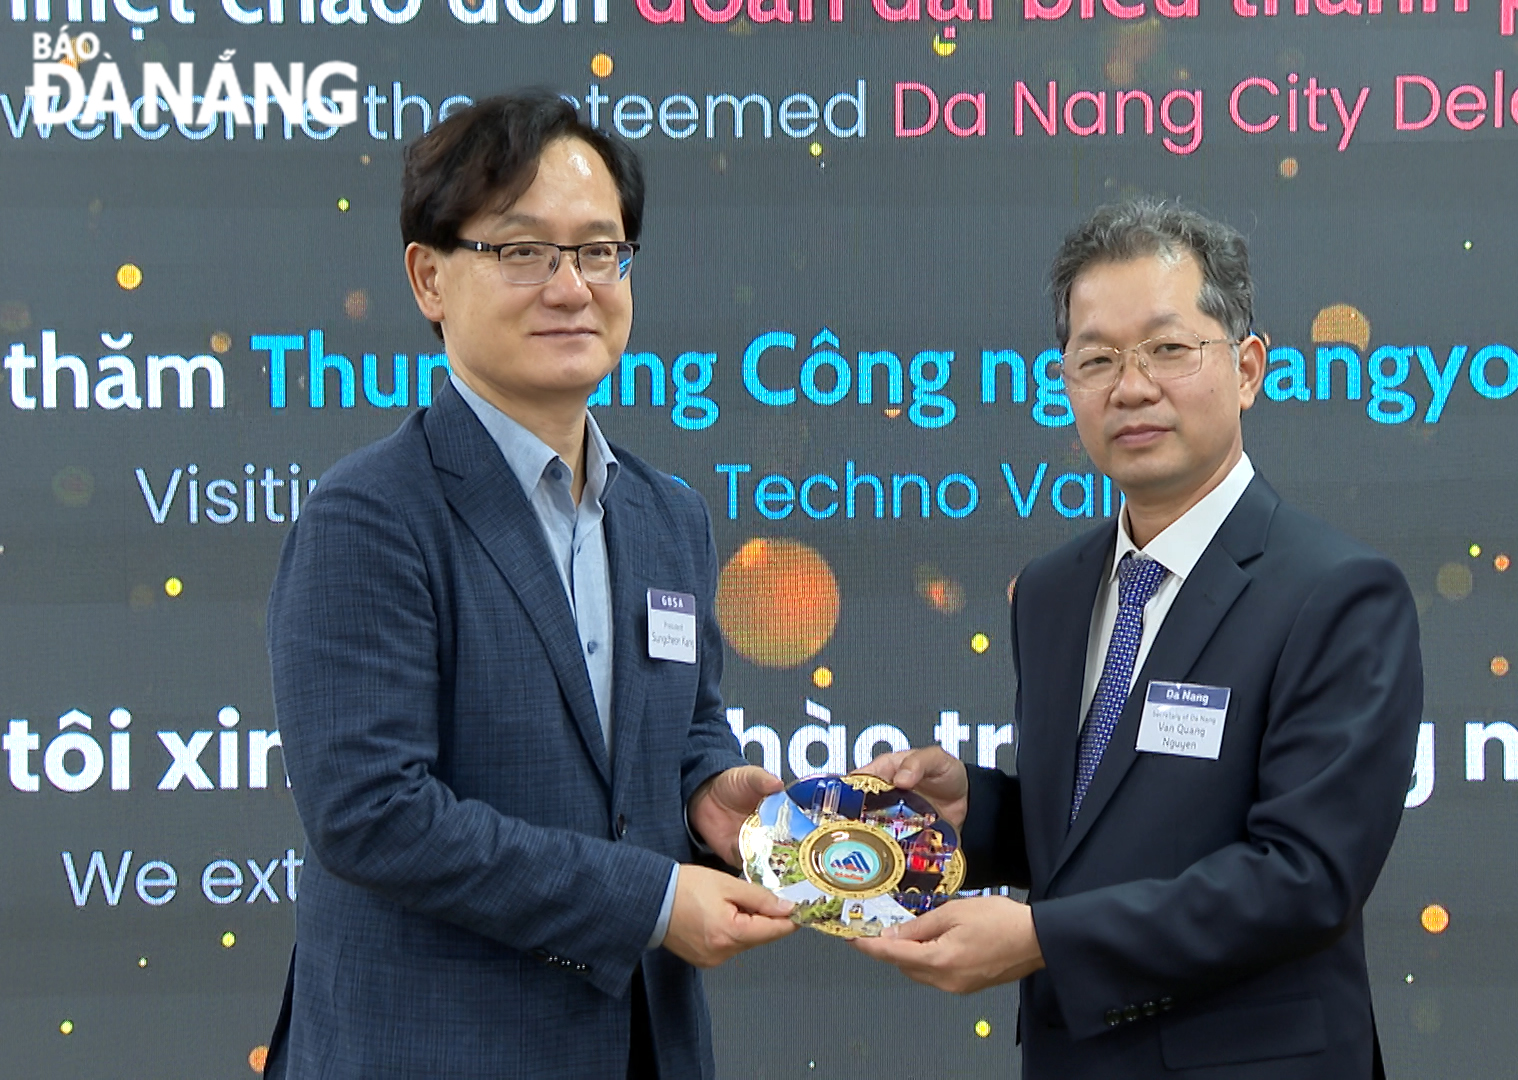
[1078,454,1254,726]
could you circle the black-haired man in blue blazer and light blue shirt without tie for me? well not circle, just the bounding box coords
[269,94,794,1080]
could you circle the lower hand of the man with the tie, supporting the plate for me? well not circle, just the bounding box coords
[852,896,1044,993]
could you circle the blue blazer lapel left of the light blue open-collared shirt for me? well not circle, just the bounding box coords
[424,384,621,787]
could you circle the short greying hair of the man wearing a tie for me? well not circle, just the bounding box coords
[1049,199,1254,349]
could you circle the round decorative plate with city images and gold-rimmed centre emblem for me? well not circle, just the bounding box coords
[738,773,964,937]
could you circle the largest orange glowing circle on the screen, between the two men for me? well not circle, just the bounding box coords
[716,538,839,667]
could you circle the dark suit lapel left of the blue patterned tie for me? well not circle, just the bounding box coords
[1017,526,1117,881]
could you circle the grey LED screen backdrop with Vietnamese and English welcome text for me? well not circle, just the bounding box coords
[0,0,1518,1080]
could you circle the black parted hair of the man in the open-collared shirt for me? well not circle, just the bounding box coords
[401,90,644,337]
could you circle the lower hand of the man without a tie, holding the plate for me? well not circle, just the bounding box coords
[663,863,795,968]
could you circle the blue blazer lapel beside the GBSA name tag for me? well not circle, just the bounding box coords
[603,483,653,775]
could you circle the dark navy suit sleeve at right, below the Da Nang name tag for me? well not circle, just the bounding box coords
[1032,556,1422,1039]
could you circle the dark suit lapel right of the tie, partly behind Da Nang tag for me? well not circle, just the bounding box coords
[1050,475,1280,878]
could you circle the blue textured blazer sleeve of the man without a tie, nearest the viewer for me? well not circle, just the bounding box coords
[269,477,672,995]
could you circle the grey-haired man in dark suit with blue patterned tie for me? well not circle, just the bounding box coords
[859,202,1422,1080]
